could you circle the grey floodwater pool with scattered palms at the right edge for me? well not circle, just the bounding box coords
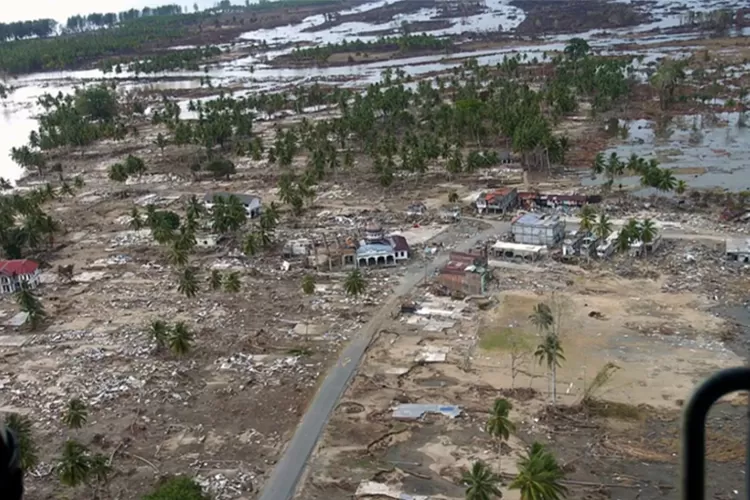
[582,112,750,195]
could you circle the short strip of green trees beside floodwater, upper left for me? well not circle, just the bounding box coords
[99,45,221,76]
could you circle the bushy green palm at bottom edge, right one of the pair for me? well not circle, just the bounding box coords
[510,443,568,500]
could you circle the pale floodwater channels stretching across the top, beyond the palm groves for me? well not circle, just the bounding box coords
[0,0,748,180]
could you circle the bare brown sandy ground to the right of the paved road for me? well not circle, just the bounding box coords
[298,250,744,500]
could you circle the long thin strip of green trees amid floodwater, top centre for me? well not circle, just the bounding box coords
[289,34,453,62]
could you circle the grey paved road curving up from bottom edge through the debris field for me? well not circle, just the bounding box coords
[259,221,500,500]
